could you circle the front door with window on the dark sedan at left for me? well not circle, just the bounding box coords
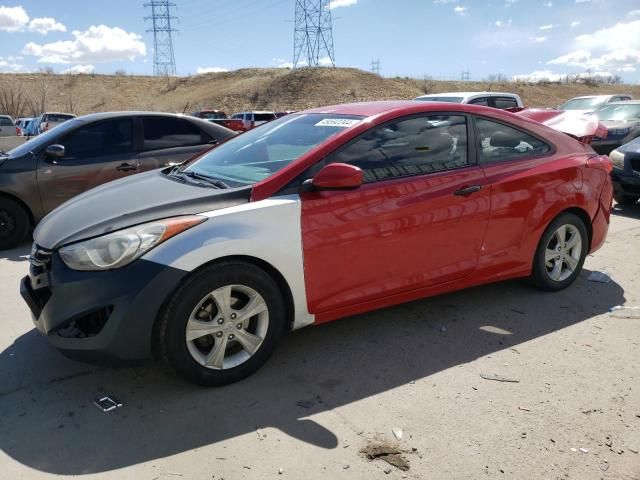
[37,118,139,213]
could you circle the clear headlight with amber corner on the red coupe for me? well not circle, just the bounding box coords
[60,215,206,271]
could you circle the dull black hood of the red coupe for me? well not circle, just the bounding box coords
[33,170,251,250]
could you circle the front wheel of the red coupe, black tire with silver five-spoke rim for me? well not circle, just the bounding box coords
[156,261,286,386]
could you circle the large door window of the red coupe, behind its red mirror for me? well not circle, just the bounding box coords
[327,115,468,183]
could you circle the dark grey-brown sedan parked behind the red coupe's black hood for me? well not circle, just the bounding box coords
[0,112,234,249]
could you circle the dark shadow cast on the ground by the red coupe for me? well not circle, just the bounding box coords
[0,271,625,475]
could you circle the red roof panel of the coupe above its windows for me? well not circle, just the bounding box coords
[298,100,496,117]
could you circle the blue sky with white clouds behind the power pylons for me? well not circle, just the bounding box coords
[0,0,640,83]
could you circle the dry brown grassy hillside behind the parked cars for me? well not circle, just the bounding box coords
[5,68,640,114]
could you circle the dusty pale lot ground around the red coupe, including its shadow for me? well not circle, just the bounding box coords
[0,207,640,480]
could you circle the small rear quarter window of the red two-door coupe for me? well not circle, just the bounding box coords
[475,118,551,162]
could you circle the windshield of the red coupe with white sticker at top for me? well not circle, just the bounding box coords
[184,114,363,187]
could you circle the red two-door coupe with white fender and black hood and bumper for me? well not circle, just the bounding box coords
[21,101,612,385]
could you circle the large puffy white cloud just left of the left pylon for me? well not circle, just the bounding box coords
[22,25,147,64]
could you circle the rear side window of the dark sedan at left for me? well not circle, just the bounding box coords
[142,117,202,150]
